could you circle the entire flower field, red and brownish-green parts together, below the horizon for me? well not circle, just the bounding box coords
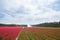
[0,27,60,40]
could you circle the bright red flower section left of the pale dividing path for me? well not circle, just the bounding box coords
[0,27,22,40]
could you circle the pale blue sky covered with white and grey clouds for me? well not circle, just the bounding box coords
[0,0,60,24]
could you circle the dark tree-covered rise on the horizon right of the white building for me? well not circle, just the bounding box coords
[33,21,60,27]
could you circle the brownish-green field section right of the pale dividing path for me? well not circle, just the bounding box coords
[18,28,60,40]
